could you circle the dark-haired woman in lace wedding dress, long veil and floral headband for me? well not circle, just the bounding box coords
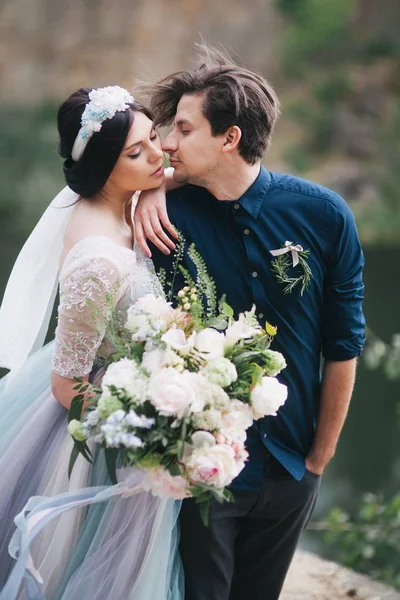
[0,86,183,600]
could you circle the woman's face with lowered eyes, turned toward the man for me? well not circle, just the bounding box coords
[109,112,164,192]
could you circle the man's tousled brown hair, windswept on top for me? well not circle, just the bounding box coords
[140,44,279,164]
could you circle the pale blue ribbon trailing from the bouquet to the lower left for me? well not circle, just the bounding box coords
[0,478,144,600]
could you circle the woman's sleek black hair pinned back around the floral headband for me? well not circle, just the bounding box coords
[57,88,153,198]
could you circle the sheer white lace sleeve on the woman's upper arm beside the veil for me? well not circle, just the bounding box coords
[52,256,123,378]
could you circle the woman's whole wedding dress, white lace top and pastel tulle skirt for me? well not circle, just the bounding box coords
[0,237,183,600]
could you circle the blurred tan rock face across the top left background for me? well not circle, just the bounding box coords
[0,0,279,105]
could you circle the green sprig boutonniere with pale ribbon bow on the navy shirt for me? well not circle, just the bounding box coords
[270,242,312,296]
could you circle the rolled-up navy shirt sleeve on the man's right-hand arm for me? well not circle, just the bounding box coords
[322,195,365,361]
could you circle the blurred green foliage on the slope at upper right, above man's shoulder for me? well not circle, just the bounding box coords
[275,0,400,245]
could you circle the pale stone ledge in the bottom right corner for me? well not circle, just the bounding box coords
[280,550,400,600]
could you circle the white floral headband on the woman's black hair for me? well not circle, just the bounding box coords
[71,85,134,162]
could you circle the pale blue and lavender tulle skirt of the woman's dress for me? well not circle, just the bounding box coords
[0,343,184,600]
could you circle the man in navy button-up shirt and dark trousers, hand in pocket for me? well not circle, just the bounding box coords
[135,51,365,600]
